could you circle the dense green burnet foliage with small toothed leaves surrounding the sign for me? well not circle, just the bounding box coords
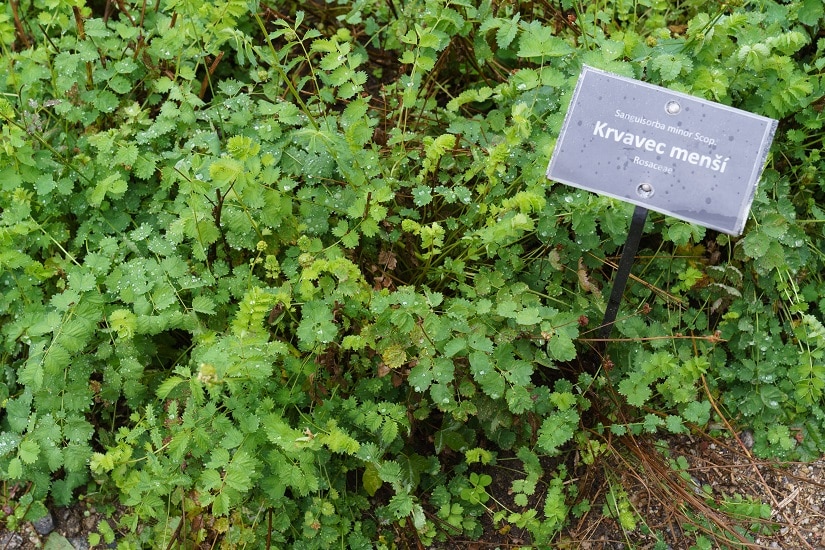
[0,0,825,549]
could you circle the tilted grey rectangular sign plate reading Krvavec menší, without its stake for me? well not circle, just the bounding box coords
[547,66,777,235]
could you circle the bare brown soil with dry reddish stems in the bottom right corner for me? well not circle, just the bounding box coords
[567,433,825,550]
